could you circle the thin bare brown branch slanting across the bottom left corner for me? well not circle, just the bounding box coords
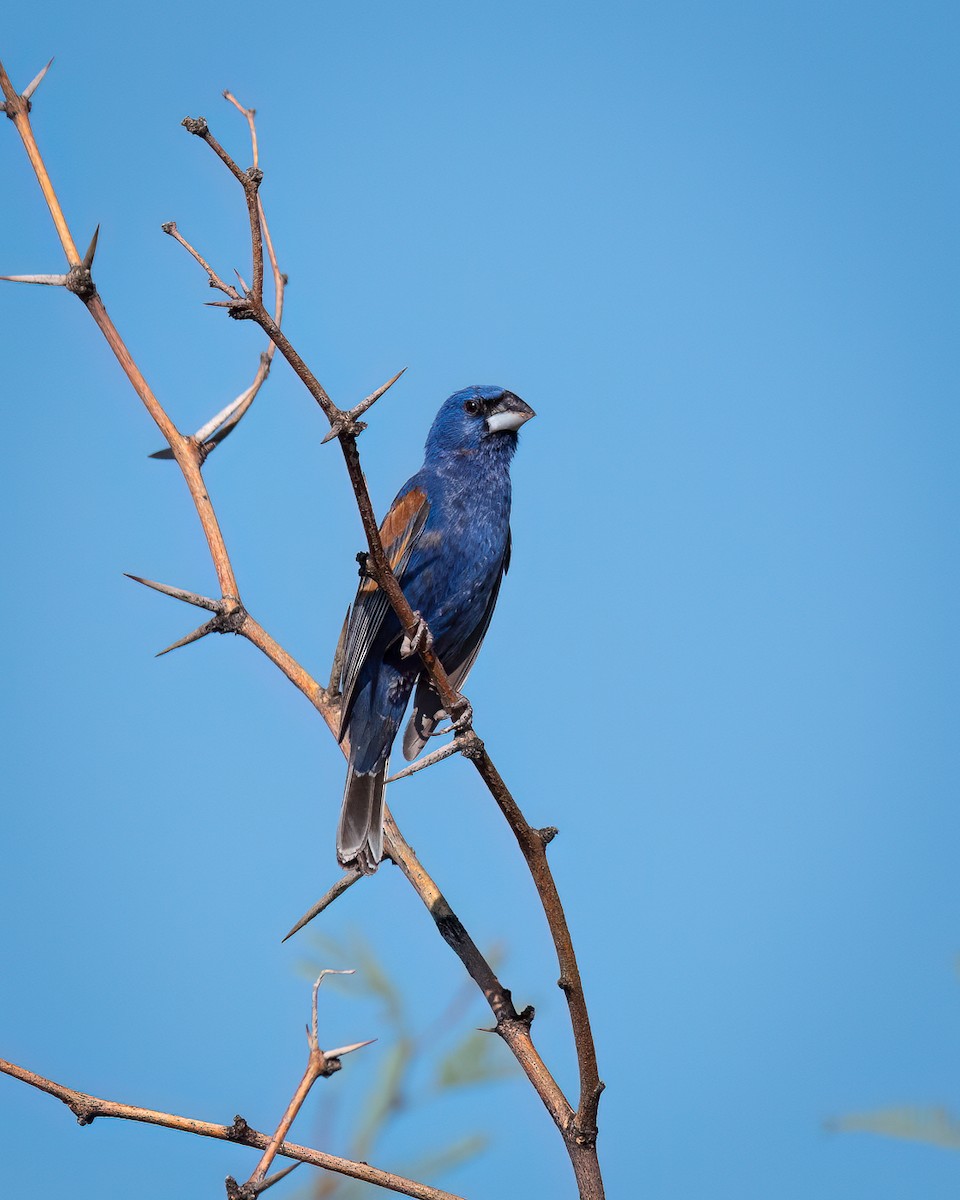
[0,1058,462,1200]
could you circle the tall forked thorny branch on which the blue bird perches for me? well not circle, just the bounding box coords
[0,58,604,1200]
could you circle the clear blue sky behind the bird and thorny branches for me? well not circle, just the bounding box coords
[0,0,960,1200]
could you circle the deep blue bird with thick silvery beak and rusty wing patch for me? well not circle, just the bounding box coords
[337,384,536,875]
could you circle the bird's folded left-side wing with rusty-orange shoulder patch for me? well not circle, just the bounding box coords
[340,487,430,740]
